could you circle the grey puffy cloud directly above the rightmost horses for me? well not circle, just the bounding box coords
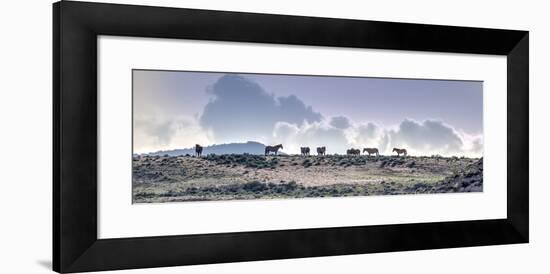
[390,119,463,154]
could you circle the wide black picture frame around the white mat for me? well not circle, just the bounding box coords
[53,1,529,273]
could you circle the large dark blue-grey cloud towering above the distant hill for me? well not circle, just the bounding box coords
[200,74,322,142]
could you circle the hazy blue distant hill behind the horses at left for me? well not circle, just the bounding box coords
[144,141,265,156]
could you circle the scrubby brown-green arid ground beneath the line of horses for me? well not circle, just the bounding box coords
[133,154,483,203]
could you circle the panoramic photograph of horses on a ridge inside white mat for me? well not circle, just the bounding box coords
[132,69,483,203]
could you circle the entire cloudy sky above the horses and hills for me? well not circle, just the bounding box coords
[133,70,483,157]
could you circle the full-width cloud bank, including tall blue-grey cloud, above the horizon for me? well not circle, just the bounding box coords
[134,74,483,157]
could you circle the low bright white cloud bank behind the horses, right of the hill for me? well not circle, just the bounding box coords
[270,116,483,157]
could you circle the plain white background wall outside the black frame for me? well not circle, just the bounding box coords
[0,0,550,274]
